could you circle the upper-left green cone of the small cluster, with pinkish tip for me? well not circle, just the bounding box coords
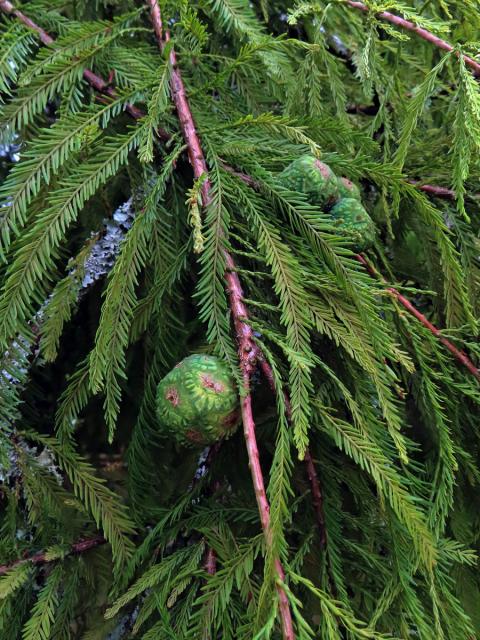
[278,155,340,209]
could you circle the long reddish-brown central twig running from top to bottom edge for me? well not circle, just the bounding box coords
[149,0,295,640]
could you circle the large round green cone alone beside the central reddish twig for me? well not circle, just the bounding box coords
[156,354,240,446]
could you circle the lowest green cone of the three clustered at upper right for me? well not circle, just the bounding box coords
[329,198,375,251]
